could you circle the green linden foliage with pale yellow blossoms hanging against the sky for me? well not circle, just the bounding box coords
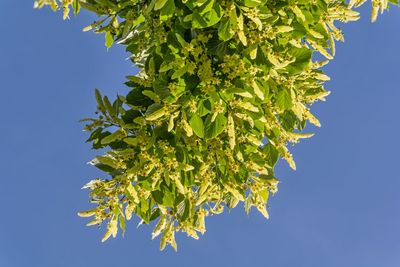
[35,0,397,249]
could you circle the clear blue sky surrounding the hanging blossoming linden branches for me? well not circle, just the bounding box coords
[0,0,400,267]
